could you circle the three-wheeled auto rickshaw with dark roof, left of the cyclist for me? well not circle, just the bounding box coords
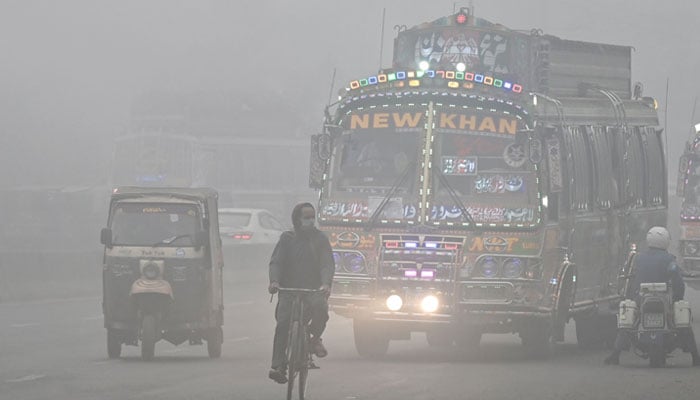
[100,187,223,360]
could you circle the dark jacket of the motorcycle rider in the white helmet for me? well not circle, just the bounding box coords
[628,247,685,301]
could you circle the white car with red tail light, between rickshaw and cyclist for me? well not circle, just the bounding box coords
[219,208,287,247]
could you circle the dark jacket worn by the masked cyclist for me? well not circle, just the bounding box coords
[270,228,335,289]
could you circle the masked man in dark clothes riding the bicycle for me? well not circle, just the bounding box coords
[268,203,335,383]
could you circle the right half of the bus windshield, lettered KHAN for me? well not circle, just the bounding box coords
[430,108,538,225]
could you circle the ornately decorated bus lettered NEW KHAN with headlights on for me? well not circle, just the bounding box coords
[310,9,667,356]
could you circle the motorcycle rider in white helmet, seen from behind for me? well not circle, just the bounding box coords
[605,226,700,366]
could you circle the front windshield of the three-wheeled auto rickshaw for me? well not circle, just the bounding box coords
[111,203,201,247]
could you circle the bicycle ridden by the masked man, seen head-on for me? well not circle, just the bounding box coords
[278,288,322,400]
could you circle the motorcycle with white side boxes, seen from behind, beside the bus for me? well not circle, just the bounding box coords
[618,283,691,368]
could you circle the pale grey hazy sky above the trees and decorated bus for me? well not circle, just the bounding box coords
[0,0,700,185]
